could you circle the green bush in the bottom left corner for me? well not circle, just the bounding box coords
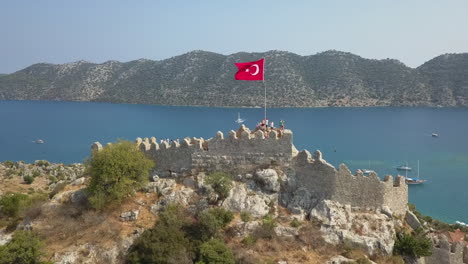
[0,231,45,264]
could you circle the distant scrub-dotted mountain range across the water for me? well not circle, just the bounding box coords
[0,51,468,107]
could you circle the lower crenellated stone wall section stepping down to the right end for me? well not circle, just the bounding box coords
[294,151,408,215]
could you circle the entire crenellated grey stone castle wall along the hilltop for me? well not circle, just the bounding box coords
[92,126,408,215]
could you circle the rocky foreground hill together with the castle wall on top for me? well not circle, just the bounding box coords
[0,126,468,264]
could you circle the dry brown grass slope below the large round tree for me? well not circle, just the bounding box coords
[35,190,157,257]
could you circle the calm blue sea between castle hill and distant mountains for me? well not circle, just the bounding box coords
[0,101,468,222]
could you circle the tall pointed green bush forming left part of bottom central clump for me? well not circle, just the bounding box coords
[126,206,194,264]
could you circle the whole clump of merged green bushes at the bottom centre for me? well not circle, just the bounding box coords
[126,205,234,264]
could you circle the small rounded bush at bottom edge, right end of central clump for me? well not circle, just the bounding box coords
[196,239,236,264]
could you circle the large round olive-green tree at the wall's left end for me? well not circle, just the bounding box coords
[86,141,154,209]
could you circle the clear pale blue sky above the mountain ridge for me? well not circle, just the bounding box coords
[0,0,468,73]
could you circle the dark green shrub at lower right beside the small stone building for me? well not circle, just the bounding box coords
[393,231,432,258]
